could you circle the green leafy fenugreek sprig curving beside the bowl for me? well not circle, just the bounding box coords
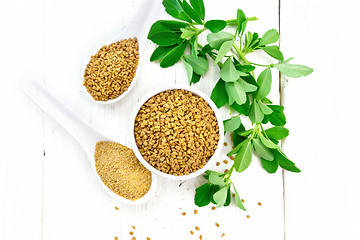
[148,0,313,210]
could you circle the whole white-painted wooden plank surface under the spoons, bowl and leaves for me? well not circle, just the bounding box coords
[0,0,360,240]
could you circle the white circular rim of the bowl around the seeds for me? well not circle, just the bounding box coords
[129,85,224,180]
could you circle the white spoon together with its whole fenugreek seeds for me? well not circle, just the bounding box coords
[83,0,161,104]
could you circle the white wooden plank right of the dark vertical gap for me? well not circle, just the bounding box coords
[281,0,360,240]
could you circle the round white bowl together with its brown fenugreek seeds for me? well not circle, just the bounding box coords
[130,88,224,180]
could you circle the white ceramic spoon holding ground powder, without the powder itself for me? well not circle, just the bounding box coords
[23,81,156,204]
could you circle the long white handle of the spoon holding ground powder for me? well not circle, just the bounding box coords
[23,80,106,159]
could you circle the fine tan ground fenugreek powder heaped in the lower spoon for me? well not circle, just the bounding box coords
[95,141,152,200]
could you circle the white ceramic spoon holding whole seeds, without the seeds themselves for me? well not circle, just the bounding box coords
[81,0,162,104]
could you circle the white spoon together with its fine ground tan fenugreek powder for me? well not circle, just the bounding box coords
[23,81,156,204]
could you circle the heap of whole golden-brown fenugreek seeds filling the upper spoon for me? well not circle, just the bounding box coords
[83,38,139,101]
